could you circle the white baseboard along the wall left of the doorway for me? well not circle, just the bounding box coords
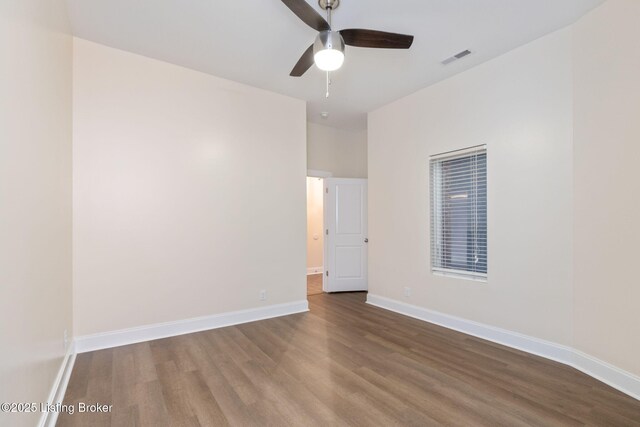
[75,300,309,353]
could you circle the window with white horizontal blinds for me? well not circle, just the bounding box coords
[430,146,487,280]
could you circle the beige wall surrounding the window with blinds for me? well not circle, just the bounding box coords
[368,29,573,344]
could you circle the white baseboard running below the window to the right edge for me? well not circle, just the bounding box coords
[367,293,640,400]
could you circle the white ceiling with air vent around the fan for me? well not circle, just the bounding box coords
[68,0,603,129]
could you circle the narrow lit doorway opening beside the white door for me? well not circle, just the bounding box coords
[307,176,324,295]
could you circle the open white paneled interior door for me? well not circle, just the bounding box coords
[323,178,368,292]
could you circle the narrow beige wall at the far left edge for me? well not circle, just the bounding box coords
[0,0,72,426]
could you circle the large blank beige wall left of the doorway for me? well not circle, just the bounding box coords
[73,39,306,336]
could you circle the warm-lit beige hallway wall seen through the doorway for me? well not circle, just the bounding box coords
[307,178,324,272]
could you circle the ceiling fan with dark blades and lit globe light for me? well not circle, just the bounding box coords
[282,0,413,77]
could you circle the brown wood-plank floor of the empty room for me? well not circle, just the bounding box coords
[58,293,640,427]
